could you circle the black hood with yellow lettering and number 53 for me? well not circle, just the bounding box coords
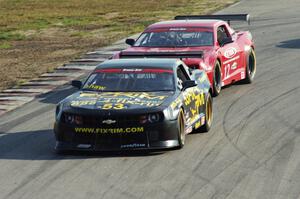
[65,91,174,111]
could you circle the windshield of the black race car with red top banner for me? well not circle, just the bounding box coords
[83,68,175,92]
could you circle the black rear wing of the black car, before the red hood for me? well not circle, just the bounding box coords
[120,51,203,59]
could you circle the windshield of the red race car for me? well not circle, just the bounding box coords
[134,30,213,47]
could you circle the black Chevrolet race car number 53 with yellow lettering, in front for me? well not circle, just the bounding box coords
[54,59,213,152]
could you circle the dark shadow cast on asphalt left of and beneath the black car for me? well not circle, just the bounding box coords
[0,129,165,160]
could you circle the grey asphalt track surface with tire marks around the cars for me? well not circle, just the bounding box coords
[0,0,300,199]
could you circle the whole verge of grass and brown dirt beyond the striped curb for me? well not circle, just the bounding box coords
[0,0,237,89]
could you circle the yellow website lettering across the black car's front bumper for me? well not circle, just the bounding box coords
[74,127,144,134]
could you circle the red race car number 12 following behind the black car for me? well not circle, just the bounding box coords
[113,14,256,96]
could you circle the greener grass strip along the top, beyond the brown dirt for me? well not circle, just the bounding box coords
[0,0,236,39]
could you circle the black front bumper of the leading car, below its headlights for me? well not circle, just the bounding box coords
[54,120,179,151]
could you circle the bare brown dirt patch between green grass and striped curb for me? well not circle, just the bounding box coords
[0,30,107,90]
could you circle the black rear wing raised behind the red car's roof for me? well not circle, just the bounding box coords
[174,14,250,25]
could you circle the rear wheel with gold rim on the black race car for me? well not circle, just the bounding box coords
[194,93,214,133]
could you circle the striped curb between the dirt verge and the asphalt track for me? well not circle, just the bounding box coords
[0,34,138,116]
